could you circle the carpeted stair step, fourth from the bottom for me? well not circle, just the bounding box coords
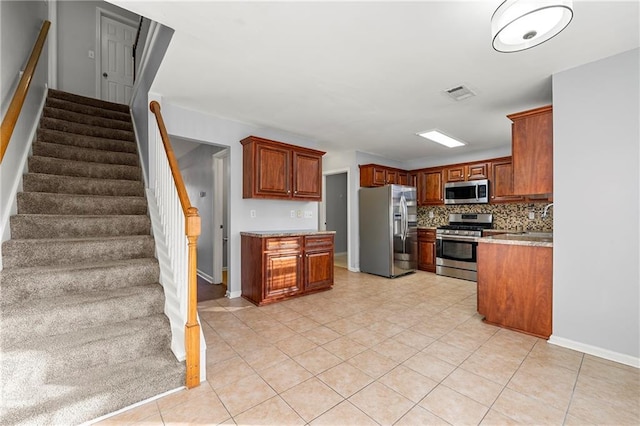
[0,257,160,306]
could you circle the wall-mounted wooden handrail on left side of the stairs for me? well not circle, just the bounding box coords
[0,21,51,164]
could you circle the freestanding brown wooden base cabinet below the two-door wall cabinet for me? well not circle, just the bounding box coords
[241,234,334,306]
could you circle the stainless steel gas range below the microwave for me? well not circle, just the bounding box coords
[436,213,493,281]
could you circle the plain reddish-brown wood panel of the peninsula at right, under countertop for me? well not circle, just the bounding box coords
[477,242,553,339]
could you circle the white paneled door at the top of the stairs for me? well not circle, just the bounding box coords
[100,16,137,104]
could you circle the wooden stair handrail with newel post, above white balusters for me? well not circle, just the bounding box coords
[149,101,201,389]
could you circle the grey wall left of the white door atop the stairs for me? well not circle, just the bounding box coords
[57,0,139,98]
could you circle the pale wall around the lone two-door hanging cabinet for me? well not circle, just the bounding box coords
[150,100,318,297]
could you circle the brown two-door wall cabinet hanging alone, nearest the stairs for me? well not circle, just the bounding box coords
[240,136,325,201]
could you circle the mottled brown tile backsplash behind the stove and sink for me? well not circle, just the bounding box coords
[418,203,553,232]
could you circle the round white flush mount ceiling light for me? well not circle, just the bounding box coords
[491,0,573,52]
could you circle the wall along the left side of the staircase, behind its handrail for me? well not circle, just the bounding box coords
[0,1,48,269]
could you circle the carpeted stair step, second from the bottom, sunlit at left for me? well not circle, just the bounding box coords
[2,314,171,383]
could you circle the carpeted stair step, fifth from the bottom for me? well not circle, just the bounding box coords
[2,235,155,268]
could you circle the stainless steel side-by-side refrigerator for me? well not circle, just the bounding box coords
[359,185,418,278]
